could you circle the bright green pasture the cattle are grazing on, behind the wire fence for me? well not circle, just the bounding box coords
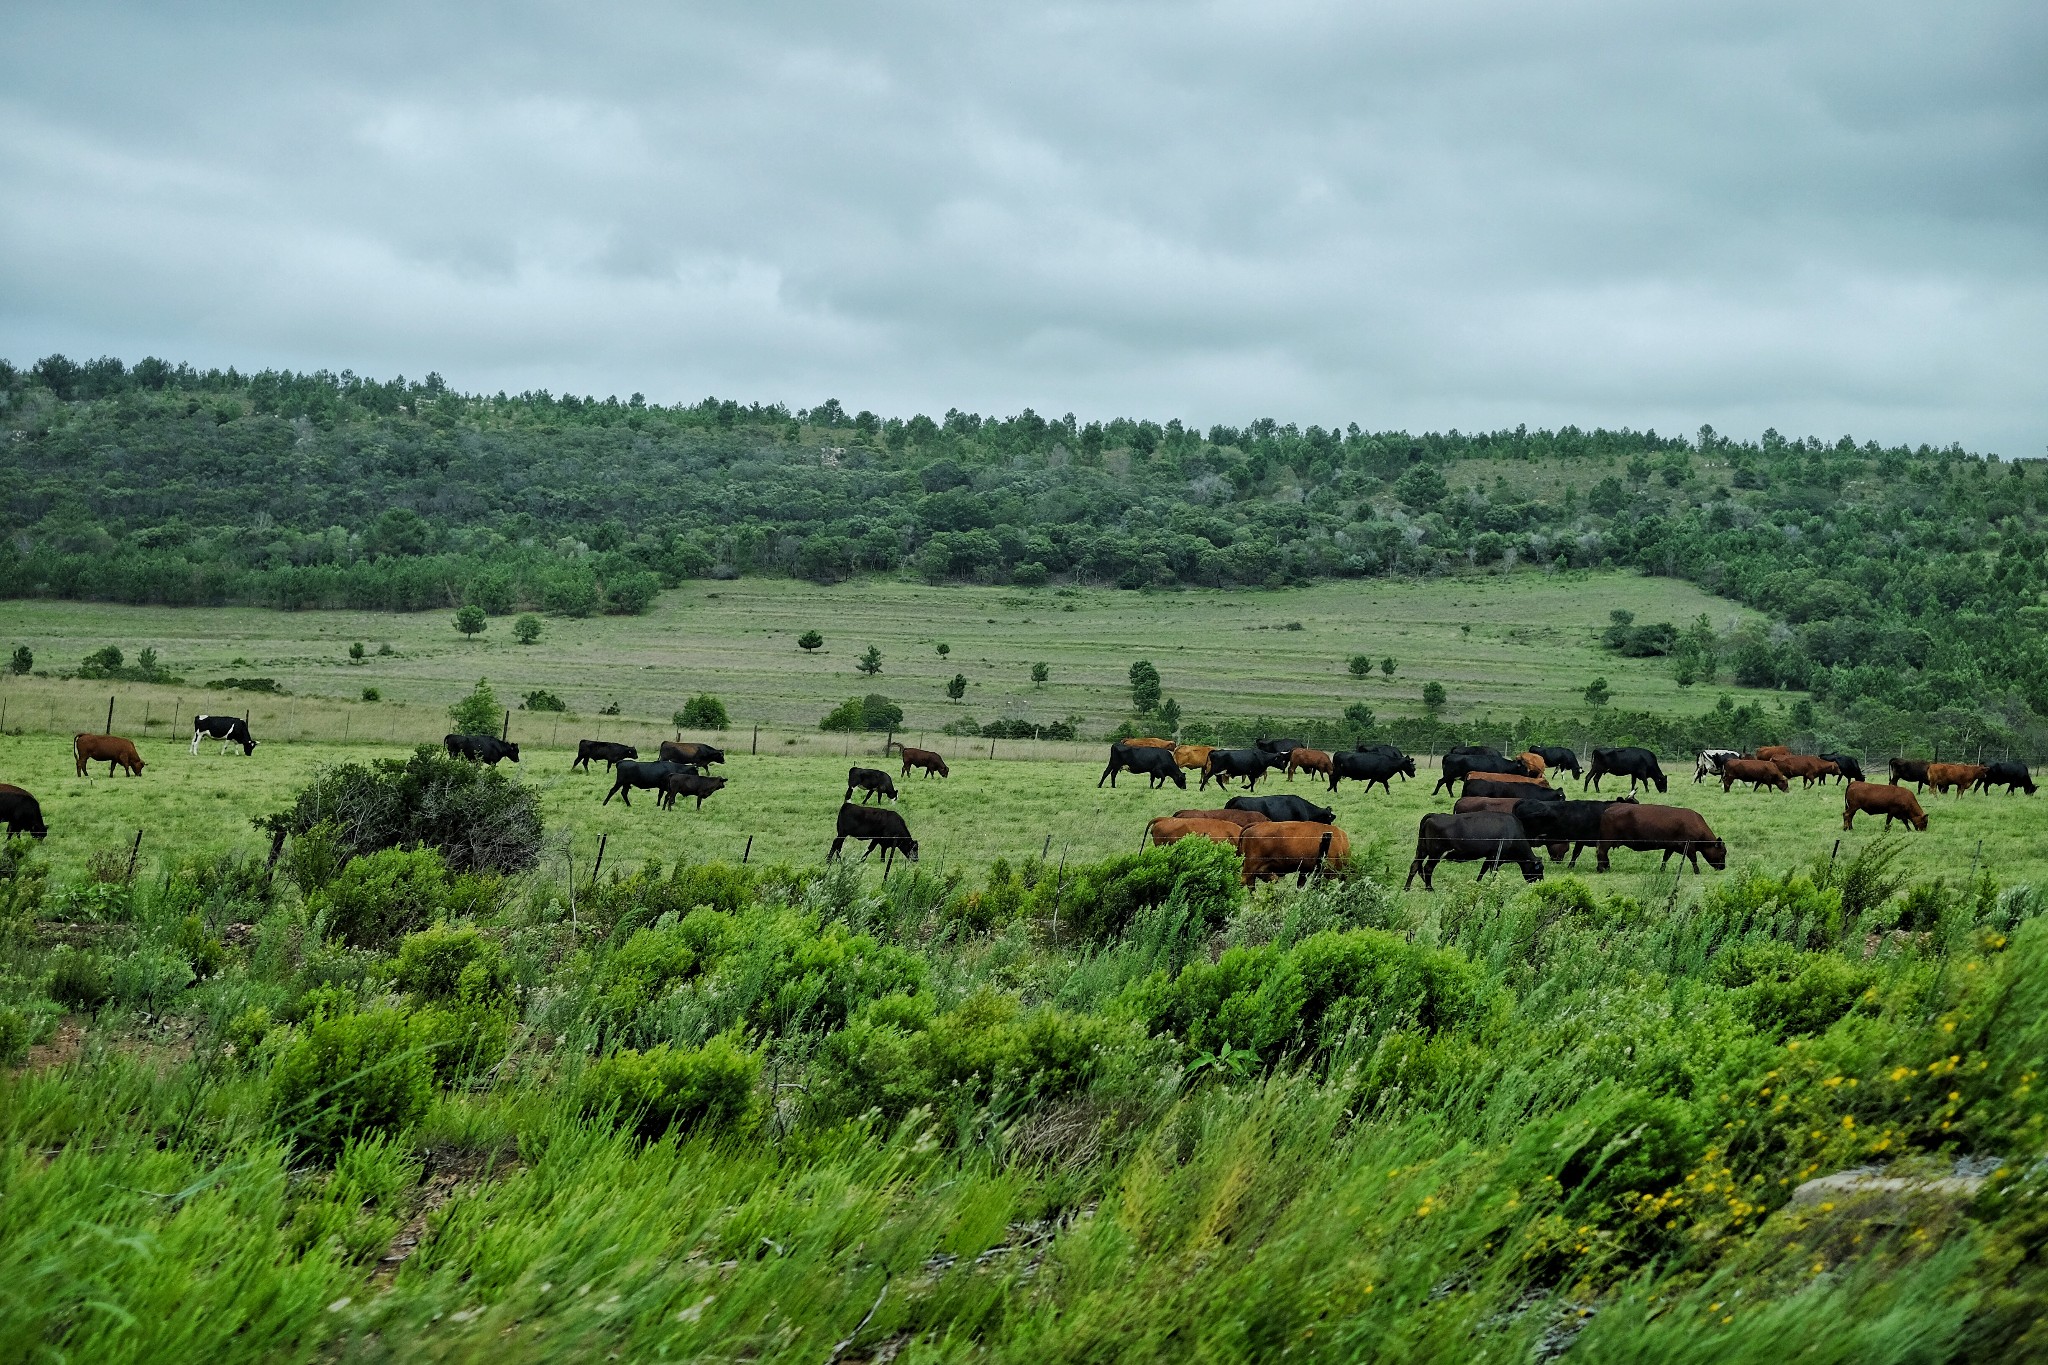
[0,735,2048,900]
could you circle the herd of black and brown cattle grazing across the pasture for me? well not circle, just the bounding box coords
[0,716,2036,890]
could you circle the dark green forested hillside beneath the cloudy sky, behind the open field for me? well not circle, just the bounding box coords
[0,356,2048,724]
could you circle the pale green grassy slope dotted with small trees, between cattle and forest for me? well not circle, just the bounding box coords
[0,573,1753,739]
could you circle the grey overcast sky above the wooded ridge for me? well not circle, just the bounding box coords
[0,0,2048,454]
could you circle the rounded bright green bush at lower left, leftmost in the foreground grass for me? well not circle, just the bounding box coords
[270,1009,434,1156]
